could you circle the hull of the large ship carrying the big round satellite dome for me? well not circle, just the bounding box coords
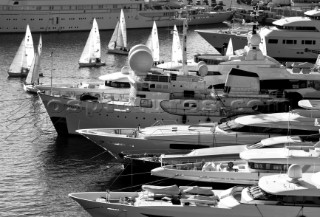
[39,93,216,135]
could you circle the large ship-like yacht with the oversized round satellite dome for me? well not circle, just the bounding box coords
[40,45,216,134]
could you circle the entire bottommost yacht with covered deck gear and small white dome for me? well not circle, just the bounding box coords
[69,165,320,217]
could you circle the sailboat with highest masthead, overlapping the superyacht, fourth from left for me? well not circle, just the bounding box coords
[108,9,129,55]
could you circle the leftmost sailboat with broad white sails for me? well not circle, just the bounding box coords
[8,25,34,77]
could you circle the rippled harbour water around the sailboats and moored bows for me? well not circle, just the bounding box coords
[0,24,222,217]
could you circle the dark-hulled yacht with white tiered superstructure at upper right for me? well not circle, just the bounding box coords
[196,8,320,61]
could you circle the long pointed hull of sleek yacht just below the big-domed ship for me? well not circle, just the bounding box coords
[77,127,272,155]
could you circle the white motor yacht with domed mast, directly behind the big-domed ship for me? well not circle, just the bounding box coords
[155,25,320,107]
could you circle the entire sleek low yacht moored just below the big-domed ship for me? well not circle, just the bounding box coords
[77,107,319,158]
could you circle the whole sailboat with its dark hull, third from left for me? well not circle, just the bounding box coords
[79,19,106,67]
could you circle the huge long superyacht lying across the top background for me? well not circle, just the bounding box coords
[0,0,233,33]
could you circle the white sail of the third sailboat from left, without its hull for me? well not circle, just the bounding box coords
[79,19,100,63]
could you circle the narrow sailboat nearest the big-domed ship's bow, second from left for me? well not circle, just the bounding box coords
[23,35,42,93]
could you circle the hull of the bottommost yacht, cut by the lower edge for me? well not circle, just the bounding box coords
[69,192,319,217]
